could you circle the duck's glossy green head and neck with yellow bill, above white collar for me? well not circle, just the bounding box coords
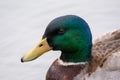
[21,15,92,63]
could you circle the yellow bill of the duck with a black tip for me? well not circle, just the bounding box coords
[21,38,51,62]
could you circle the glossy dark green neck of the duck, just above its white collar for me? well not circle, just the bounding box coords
[60,49,91,63]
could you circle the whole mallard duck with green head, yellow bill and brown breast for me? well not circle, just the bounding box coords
[21,15,120,80]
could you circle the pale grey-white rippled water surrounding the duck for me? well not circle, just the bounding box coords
[0,0,120,80]
